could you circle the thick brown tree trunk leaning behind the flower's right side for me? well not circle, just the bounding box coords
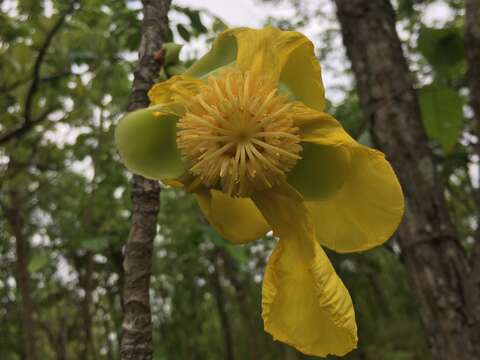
[335,0,480,360]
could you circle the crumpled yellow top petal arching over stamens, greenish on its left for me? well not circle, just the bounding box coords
[188,27,325,111]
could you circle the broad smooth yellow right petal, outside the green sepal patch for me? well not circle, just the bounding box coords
[307,146,404,252]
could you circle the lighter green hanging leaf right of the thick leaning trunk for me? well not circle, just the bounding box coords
[418,84,463,153]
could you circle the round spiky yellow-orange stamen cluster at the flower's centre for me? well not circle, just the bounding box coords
[177,69,302,197]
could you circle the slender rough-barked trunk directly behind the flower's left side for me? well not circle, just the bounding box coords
[121,0,170,360]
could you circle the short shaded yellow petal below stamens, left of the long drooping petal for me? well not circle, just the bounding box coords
[196,190,270,244]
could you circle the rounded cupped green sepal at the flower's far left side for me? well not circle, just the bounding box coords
[115,106,186,179]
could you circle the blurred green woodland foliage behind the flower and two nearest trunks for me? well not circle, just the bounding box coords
[0,0,480,360]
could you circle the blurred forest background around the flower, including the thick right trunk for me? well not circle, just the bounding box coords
[0,0,480,360]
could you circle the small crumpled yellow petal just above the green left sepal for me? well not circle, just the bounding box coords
[148,75,202,105]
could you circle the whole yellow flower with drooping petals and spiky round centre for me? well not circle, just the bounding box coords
[116,27,403,356]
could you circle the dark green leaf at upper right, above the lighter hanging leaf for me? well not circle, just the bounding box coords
[418,26,465,77]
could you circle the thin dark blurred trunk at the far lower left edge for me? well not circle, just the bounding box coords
[6,190,36,360]
